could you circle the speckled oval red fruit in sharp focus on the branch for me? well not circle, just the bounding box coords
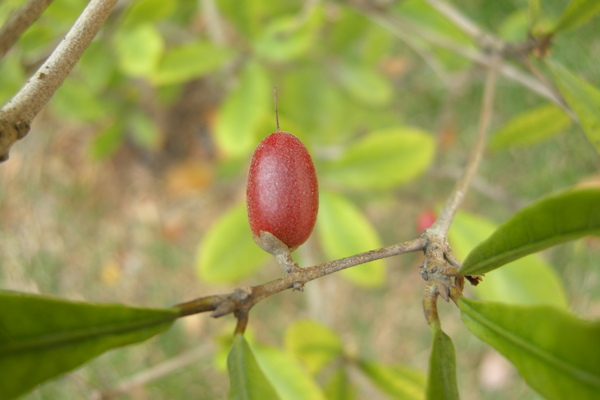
[246,130,319,250]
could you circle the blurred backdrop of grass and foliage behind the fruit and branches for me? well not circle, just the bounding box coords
[0,0,600,400]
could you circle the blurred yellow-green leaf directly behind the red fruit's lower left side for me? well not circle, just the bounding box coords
[197,204,269,283]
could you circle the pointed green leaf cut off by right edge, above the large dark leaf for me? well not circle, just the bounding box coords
[549,60,600,153]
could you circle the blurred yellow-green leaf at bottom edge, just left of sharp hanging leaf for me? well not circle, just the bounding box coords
[358,361,427,400]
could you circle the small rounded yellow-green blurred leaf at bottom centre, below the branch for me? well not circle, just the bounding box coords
[285,319,344,374]
